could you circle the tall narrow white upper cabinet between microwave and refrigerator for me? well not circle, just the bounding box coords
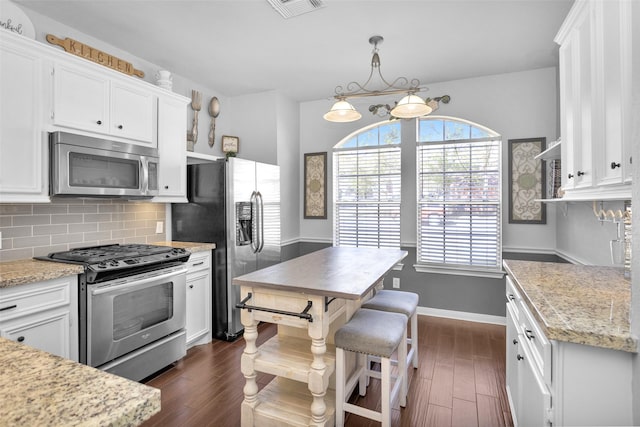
[153,96,187,203]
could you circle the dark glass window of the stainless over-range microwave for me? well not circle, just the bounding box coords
[69,153,140,189]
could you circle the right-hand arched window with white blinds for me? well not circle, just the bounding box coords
[416,117,502,271]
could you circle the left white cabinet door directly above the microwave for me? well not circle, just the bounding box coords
[53,64,110,134]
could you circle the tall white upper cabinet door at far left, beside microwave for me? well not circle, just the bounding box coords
[0,31,49,203]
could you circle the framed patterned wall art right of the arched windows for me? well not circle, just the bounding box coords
[507,138,547,224]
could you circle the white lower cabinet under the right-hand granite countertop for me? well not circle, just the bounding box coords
[506,276,635,427]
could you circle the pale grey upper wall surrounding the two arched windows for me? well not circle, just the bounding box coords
[300,68,558,251]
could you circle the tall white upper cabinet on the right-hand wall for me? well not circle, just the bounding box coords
[555,0,637,199]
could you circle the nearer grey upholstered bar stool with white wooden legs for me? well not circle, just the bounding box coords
[334,309,407,427]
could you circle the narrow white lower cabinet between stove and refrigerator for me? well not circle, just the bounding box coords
[187,251,211,347]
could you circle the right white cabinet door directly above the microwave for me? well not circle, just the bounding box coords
[110,82,156,145]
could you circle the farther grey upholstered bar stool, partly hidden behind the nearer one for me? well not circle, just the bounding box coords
[362,289,420,368]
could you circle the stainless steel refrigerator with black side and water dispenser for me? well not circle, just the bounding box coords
[171,157,280,341]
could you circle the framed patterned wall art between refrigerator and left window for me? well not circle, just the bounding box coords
[304,152,327,219]
